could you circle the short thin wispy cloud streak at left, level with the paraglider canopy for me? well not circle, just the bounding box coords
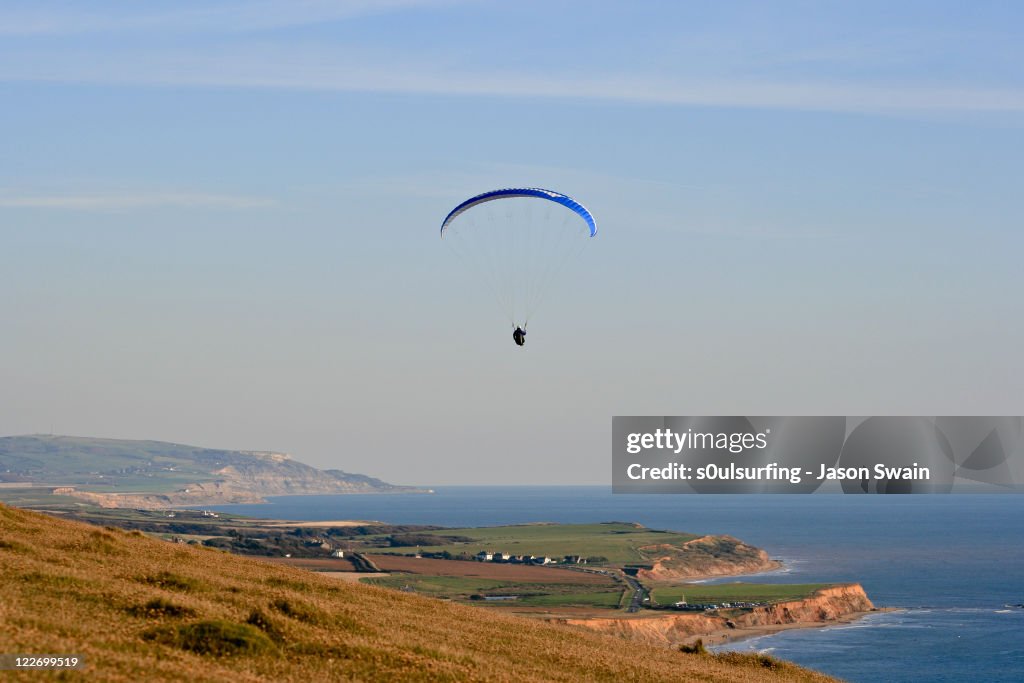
[0,191,278,211]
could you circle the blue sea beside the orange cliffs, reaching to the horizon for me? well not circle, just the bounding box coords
[209,486,1024,683]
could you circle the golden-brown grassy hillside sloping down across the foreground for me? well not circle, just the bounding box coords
[0,505,830,681]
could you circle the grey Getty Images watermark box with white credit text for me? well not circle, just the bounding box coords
[611,417,1024,494]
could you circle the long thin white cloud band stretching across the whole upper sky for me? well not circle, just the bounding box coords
[0,39,1024,114]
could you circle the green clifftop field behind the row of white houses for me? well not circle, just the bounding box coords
[366,522,697,564]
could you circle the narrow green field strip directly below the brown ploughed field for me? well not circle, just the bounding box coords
[362,574,623,609]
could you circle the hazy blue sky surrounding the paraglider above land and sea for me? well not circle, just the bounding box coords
[0,0,1024,484]
